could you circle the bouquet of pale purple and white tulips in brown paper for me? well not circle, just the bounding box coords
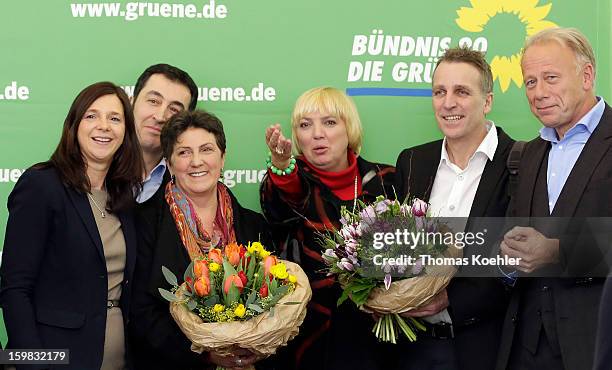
[322,196,461,343]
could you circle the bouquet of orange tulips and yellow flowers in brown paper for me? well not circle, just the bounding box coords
[159,242,312,366]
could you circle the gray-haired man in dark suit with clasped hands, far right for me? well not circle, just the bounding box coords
[497,28,612,370]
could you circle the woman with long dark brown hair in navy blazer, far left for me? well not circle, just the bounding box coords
[0,82,142,370]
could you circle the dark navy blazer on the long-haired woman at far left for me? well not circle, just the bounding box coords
[0,168,136,370]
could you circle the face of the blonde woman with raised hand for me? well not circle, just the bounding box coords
[294,112,348,172]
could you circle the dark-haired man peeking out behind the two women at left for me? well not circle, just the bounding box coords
[132,64,198,203]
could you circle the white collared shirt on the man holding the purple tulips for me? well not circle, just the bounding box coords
[423,121,498,324]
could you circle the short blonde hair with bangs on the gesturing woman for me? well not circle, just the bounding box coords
[291,86,363,154]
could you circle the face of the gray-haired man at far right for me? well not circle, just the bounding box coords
[521,41,595,137]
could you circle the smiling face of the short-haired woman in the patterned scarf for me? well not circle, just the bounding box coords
[168,127,225,198]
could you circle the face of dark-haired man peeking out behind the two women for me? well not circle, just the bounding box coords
[134,73,191,154]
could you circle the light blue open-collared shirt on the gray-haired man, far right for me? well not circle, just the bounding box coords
[540,97,606,213]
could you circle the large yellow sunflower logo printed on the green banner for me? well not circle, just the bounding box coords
[455,0,557,92]
